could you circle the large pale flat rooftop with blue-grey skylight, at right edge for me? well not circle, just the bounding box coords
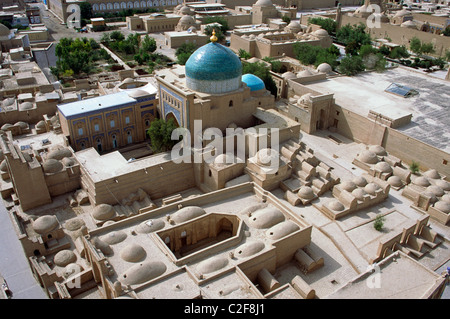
[305,67,450,152]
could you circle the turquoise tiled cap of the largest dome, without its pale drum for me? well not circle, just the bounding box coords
[186,42,242,81]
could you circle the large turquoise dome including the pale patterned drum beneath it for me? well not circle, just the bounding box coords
[185,42,242,94]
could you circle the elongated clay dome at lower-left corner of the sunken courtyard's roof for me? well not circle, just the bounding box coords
[119,261,167,285]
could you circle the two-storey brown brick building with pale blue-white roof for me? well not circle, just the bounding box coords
[58,82,157,153]
